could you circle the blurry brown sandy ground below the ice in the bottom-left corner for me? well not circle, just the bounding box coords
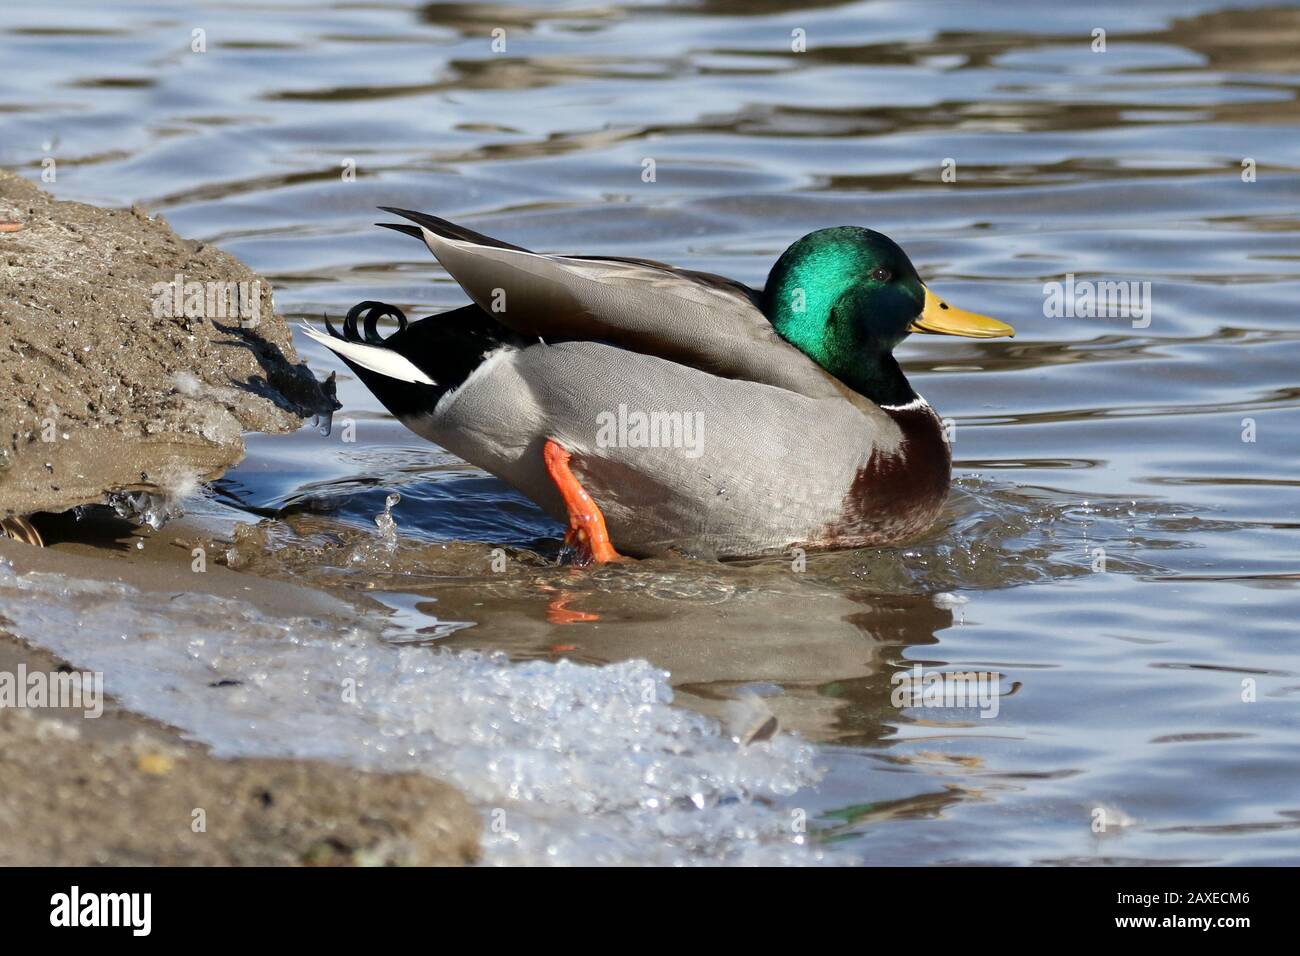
[0,709,482,866]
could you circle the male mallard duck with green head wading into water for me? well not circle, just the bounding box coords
[304,207,1014,563]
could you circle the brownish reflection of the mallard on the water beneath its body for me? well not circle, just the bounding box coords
[429,574,953,745]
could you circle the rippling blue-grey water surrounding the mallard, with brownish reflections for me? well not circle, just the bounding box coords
[0,0,1300,864]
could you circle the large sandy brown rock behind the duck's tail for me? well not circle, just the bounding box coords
[0,170,337,516]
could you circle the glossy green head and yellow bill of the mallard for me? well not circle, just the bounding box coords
[763,226,1015,405]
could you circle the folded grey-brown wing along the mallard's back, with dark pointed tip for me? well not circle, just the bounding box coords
[371,207,870,406]
